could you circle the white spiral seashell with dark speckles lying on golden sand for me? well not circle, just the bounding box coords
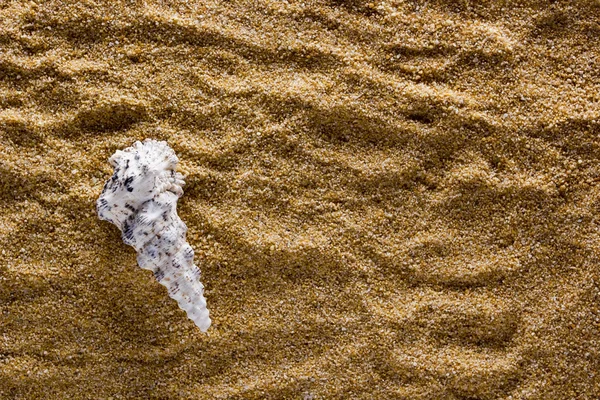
[96,139,211,332]
